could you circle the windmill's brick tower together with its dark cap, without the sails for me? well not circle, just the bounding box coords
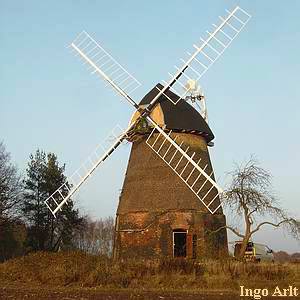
[114,85,228,259]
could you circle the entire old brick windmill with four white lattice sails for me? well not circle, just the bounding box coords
[45,7,250,258]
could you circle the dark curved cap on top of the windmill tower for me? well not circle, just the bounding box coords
[137,83,214,143]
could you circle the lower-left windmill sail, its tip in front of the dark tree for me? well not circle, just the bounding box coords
[45,125,133,216]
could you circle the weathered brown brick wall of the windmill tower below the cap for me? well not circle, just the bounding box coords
[114,133,227,258]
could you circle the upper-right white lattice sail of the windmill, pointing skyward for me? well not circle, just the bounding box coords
[160,6,251,104]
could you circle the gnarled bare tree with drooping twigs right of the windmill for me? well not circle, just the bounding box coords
[214,158,300,258]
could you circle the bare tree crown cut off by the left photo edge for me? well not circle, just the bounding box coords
[0,142,23,226]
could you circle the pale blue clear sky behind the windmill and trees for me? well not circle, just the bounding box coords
[0,0,300,252]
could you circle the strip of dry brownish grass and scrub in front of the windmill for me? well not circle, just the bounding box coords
[0,252,300,299]
